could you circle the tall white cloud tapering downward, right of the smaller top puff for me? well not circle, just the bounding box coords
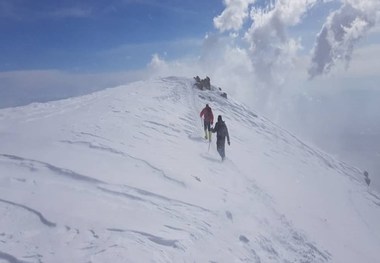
[245,0,316,85]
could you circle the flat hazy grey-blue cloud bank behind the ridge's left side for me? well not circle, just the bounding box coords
[0,70,148,109]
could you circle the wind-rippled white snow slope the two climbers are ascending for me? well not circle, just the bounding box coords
[0,77,380,262]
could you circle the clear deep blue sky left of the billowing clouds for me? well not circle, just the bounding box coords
[0,0,223,72]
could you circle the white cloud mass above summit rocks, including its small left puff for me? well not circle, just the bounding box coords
[214,0,317,86]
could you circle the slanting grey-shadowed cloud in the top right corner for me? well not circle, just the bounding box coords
[308,0,380,78]
